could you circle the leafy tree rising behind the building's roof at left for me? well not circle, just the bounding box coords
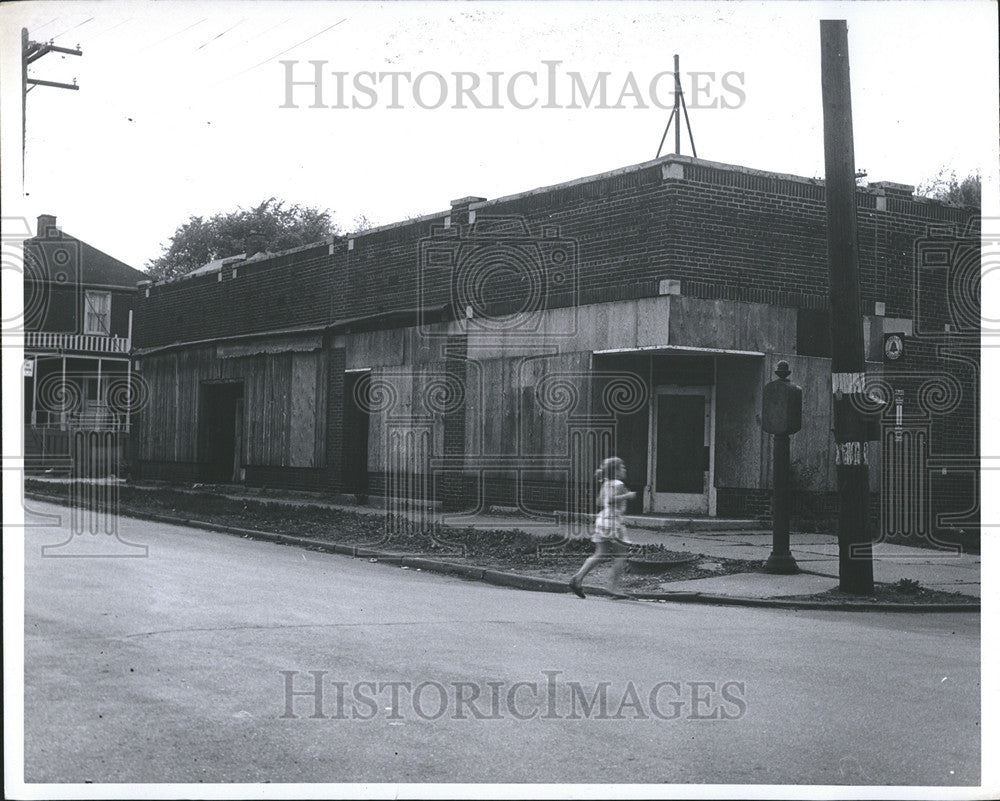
[146,197,340,280]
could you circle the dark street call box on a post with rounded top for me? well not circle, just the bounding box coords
[761,361,802,573]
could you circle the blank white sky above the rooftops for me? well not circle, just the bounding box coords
[0,0,997,269]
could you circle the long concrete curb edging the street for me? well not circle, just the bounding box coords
[24,492,981,612]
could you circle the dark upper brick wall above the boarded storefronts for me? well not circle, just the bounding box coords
[136,164,971,347]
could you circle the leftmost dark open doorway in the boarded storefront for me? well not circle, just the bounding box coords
[198,381,244,483]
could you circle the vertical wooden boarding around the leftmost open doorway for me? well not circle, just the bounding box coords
[140,347,327,468]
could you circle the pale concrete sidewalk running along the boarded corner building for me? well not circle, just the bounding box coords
[25,477,981,600]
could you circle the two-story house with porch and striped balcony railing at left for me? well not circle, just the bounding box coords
[24,214,146,472]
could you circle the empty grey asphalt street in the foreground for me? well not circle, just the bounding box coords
[24,503,980,785]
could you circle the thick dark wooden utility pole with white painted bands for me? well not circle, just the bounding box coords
[820,20,874,595]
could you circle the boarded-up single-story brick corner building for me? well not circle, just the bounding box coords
[129,155,979,535]
